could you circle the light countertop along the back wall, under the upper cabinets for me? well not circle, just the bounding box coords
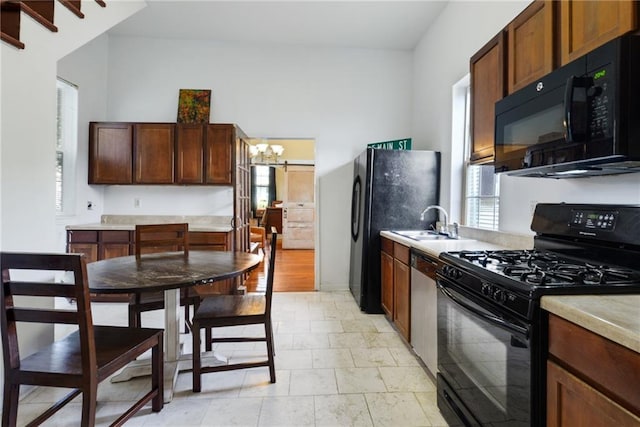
[66,215,233,233]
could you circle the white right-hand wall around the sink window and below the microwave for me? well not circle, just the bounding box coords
[413,0,640,234]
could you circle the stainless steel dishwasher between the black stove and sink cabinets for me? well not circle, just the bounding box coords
[411,249,438,377]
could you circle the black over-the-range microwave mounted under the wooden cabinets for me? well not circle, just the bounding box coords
[494,35,640,178]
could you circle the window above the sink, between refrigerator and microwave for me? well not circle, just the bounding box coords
[464,80,500,230]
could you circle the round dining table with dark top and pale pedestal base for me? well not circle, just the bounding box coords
[87,250,262,403]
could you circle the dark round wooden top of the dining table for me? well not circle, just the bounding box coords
[87,251,261,294]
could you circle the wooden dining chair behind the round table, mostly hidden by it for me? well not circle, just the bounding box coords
[129,223,200,332]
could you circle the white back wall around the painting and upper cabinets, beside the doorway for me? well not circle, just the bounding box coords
[81,37,412,289]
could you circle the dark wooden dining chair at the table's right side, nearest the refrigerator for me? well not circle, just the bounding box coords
[191,228,278,392]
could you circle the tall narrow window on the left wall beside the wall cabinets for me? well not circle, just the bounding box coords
[56,79,78,215]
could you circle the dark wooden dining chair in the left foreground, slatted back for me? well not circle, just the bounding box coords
[0,252,164,426]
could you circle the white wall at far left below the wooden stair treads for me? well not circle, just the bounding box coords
[0,1,143,394]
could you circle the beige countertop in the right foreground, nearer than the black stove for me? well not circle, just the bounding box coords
[541,295,640,353]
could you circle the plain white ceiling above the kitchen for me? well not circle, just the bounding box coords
[109,0,447,50]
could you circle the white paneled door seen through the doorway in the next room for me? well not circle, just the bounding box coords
[282,166,316,249]
